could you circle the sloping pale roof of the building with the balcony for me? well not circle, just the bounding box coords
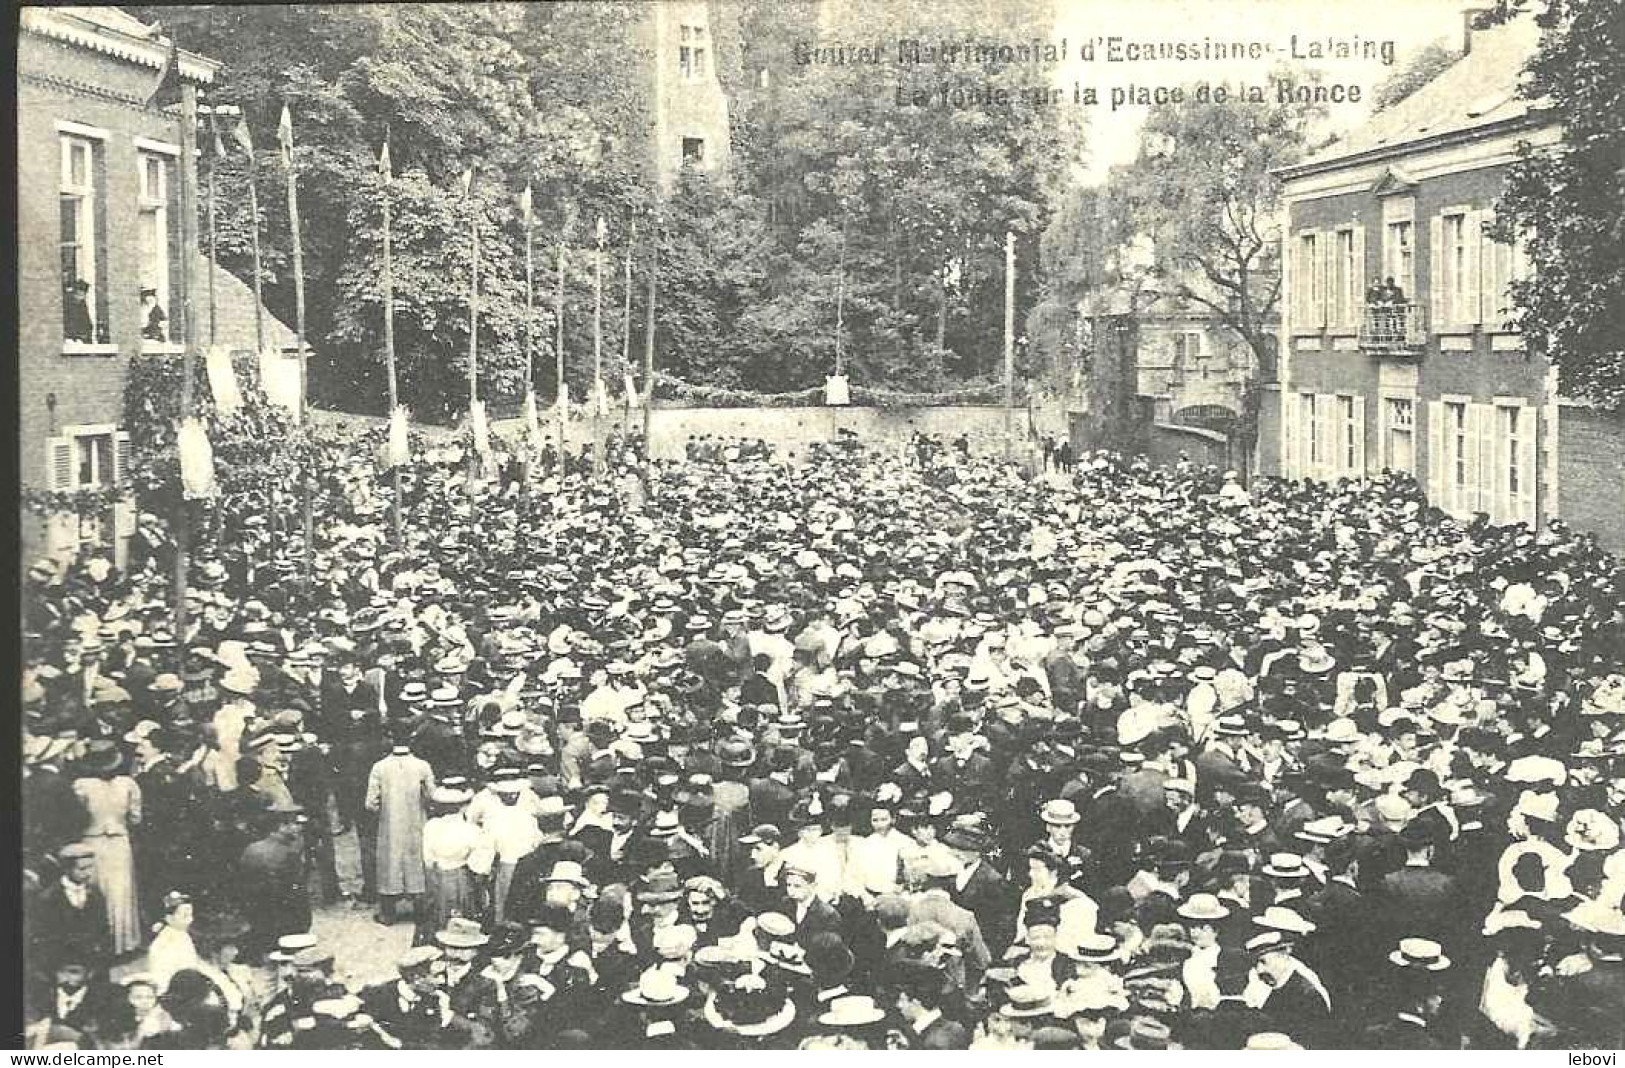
[1282,15,1541,177]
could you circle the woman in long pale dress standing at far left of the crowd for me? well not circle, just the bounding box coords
[73,743,146,956]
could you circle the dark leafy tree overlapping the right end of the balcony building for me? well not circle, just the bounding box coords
[1490,0,1625,410]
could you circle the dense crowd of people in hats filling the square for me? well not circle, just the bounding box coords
[23,437,1625,1048]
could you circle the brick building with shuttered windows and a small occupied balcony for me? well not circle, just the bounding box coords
[1259,18,1625,548]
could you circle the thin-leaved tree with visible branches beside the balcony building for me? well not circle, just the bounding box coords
[1108,73,1320,447]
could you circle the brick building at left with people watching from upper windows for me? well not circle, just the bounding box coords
[16,8,294,564]
